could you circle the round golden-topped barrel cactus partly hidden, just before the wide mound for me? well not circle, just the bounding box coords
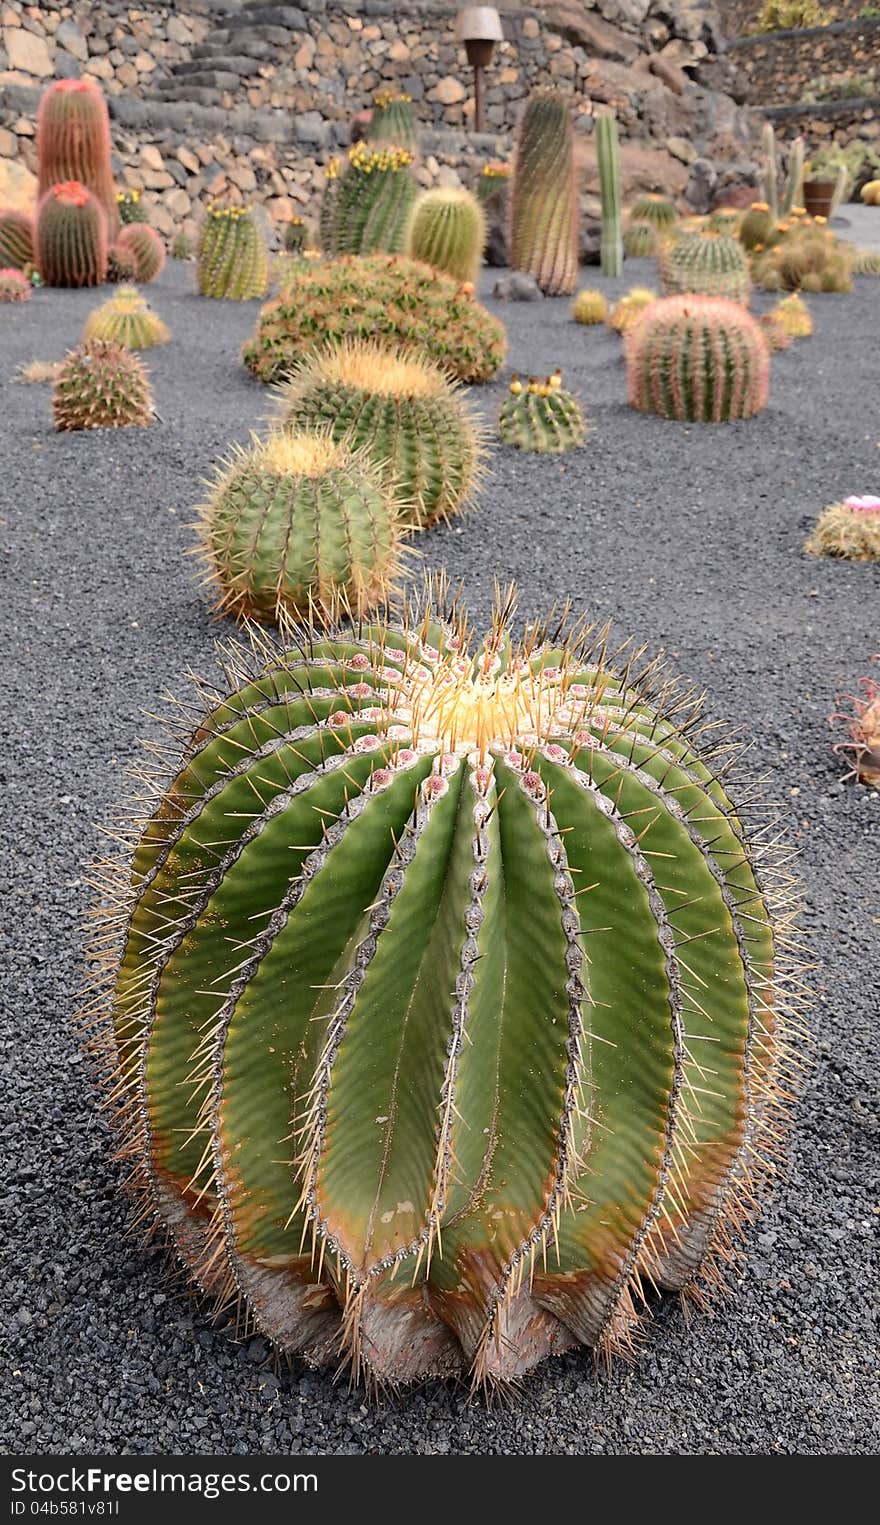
[281,340,482,529]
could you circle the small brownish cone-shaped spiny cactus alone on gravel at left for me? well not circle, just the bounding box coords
[52,340,153,430]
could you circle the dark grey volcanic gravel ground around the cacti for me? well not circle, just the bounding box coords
[0,262,880,1455]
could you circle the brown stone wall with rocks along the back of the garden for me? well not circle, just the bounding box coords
[0,0,753,235]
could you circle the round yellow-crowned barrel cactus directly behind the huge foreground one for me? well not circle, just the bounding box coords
[200,433,401,622]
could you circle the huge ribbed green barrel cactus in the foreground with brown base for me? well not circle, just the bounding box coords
[96,587,796,1386]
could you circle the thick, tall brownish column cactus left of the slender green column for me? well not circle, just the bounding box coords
[511,90,578,296]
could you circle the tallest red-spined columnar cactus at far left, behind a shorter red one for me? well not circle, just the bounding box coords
[37,79,119,239]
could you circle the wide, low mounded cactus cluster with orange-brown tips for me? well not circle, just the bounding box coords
[244,255,506,381]
